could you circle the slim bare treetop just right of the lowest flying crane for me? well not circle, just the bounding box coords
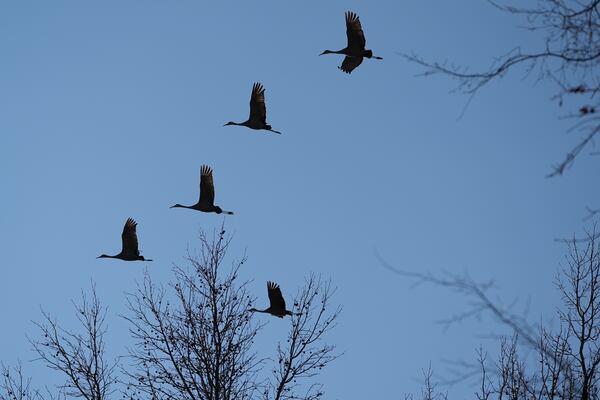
[263,275,342,400]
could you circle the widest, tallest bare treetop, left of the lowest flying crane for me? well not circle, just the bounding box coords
[125,230,260,400]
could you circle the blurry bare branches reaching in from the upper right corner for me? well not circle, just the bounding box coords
[402,0,600,177]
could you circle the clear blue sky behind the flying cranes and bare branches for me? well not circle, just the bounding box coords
[0,0,600,399]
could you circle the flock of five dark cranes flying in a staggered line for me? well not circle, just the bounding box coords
[98,11,382,318]
